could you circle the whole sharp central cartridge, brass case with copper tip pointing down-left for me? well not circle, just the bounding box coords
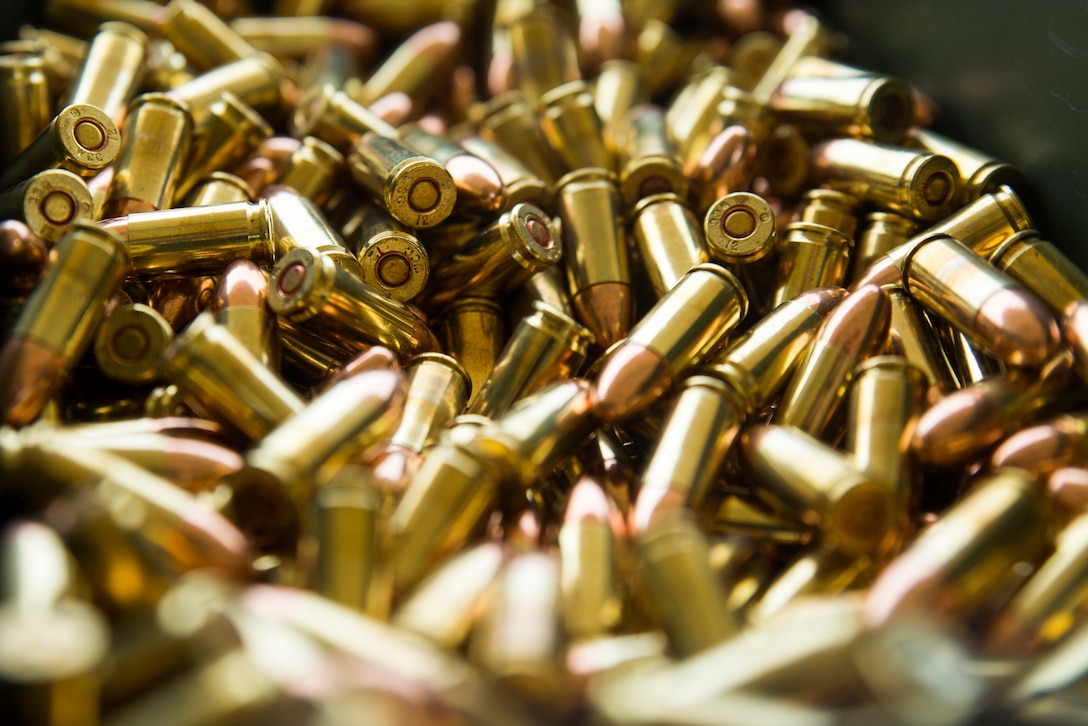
[594,262,747,421]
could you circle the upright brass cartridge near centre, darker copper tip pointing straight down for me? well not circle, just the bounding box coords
[556,168,634,348]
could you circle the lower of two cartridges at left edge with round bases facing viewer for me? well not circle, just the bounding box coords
[0,169,94,244]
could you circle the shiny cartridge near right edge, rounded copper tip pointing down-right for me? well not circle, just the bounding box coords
[903,236,1059,366]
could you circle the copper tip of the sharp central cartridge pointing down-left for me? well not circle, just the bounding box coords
[593,343,673,422]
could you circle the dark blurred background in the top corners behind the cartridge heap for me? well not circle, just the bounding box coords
[0,0,1088,269]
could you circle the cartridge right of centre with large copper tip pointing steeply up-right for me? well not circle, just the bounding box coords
[775,286,891,440]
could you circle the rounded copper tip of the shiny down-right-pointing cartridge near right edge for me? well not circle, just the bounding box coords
[975,287,1061,366]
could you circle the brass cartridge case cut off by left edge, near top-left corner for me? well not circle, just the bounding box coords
[0,54,51,167]
